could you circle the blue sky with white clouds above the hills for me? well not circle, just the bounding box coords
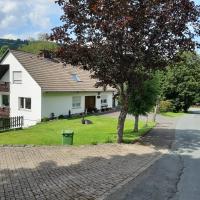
[0,0,200,39]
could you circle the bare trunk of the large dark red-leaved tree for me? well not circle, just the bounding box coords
[117,109,127,144]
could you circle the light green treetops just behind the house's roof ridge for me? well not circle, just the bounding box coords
[19,41,58,54]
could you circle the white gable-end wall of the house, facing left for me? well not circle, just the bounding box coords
[2,53,41,127]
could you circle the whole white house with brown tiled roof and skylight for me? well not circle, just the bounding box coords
[0,50,114,127]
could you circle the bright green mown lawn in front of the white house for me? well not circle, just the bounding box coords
[0,116,155,145]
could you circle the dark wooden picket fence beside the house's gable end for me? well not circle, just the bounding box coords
[0,116,24,131]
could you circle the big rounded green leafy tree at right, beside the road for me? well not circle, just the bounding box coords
[163,52,200,112]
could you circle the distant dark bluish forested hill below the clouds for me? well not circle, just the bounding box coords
[0,38,28,49]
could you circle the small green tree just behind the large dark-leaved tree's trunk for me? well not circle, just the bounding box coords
[128,75,160,132]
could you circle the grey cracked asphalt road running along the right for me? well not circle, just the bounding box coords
[107,110,200,200]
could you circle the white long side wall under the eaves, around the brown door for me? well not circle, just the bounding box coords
[42,92,112,117]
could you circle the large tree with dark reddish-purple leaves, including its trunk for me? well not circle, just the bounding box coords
[50,0,200,143]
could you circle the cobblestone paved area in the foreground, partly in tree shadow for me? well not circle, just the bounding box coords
[0,144,162,200]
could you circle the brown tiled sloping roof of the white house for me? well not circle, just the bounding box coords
[0,50,114,92]
